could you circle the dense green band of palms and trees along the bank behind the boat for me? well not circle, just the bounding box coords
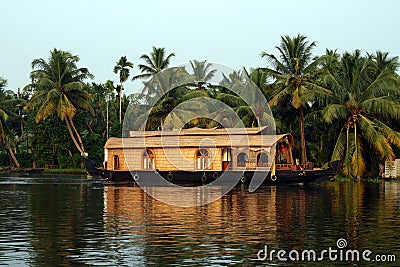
[0,35,400,179]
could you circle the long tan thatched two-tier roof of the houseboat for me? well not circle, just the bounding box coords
[104,127,293,149]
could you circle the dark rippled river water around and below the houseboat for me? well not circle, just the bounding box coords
[0,177,400,266]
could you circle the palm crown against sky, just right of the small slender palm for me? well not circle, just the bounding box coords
[132,46,175,80]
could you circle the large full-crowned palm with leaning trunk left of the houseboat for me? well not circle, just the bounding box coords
[25,49,94,157]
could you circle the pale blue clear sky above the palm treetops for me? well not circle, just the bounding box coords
[0,0,400,93]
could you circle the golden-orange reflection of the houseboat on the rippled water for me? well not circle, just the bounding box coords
[104,186,276,265]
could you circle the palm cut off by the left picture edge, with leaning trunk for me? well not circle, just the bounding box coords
[0,77,20,168]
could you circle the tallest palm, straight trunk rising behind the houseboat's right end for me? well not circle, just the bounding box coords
[261,35,329,164]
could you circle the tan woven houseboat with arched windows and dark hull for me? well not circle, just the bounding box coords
[87,127,338,184]
